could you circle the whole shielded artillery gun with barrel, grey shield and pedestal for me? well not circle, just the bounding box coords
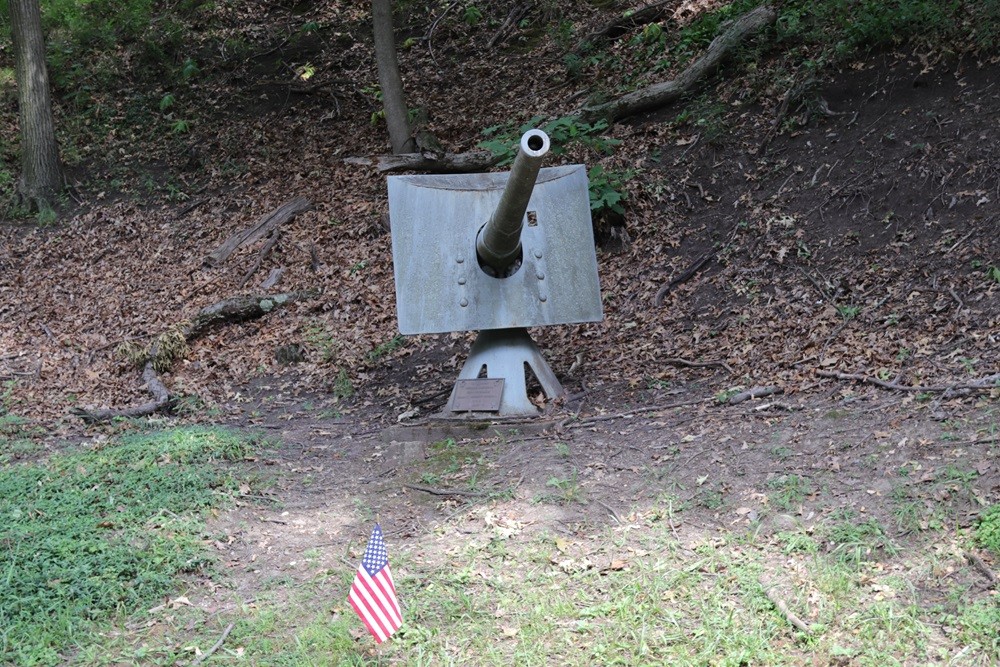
[388,130,603,418]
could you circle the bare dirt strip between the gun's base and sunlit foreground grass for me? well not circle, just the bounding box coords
[207,386,1000,599]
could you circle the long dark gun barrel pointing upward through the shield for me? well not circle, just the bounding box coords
[476,130,549,278]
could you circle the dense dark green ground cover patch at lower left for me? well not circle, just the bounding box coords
[0,428,262,665]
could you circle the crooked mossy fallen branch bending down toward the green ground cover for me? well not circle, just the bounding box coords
[70,290,319,424]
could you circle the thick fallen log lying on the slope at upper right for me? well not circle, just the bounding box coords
[580,5,777,123]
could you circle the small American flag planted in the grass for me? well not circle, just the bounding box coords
[347,524,403,644]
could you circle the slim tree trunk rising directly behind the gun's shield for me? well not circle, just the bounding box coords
[372,0,417,153]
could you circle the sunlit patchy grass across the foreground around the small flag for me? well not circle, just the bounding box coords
[72,494,1000,667]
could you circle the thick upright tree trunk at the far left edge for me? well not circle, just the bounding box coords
[7,0,63,209]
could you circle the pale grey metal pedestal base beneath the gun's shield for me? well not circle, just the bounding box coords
[442,328,563,418]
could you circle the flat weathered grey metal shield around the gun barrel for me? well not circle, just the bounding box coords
[389,165,603,335]
